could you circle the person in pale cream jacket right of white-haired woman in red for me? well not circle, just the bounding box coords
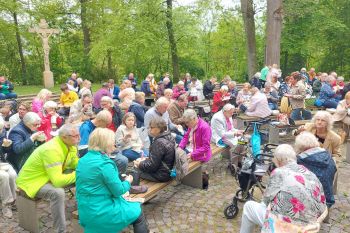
[68,94,94,123]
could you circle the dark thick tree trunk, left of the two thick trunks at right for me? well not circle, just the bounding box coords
[241,0,256,78]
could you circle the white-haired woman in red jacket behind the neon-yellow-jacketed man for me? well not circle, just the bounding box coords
[38,101,63,141]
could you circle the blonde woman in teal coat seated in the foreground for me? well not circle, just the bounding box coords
[76,128,148,233]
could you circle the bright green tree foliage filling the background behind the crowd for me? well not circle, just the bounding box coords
[0,0,350,84]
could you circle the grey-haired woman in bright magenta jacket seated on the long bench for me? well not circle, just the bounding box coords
[179,109,211,162]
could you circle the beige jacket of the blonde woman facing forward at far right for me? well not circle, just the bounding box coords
[304,123,341,157]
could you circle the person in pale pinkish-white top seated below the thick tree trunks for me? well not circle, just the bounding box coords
[240,87,271,118]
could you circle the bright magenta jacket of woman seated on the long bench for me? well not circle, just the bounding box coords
[179,118,211,162]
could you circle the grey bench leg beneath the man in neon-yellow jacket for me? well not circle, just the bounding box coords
[16,196,40,233]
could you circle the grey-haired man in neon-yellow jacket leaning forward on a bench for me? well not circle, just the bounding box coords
[16,124,80,233]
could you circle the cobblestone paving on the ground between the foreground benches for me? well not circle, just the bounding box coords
[0,153,350,233]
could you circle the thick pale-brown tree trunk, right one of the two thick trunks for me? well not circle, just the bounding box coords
[265,0,283,66]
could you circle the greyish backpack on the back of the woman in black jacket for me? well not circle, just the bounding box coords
[162,144,189,181]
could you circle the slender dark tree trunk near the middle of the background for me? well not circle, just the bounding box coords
[166,0,180,83]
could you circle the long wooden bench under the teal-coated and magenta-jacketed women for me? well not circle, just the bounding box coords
[72,143,227,233]
